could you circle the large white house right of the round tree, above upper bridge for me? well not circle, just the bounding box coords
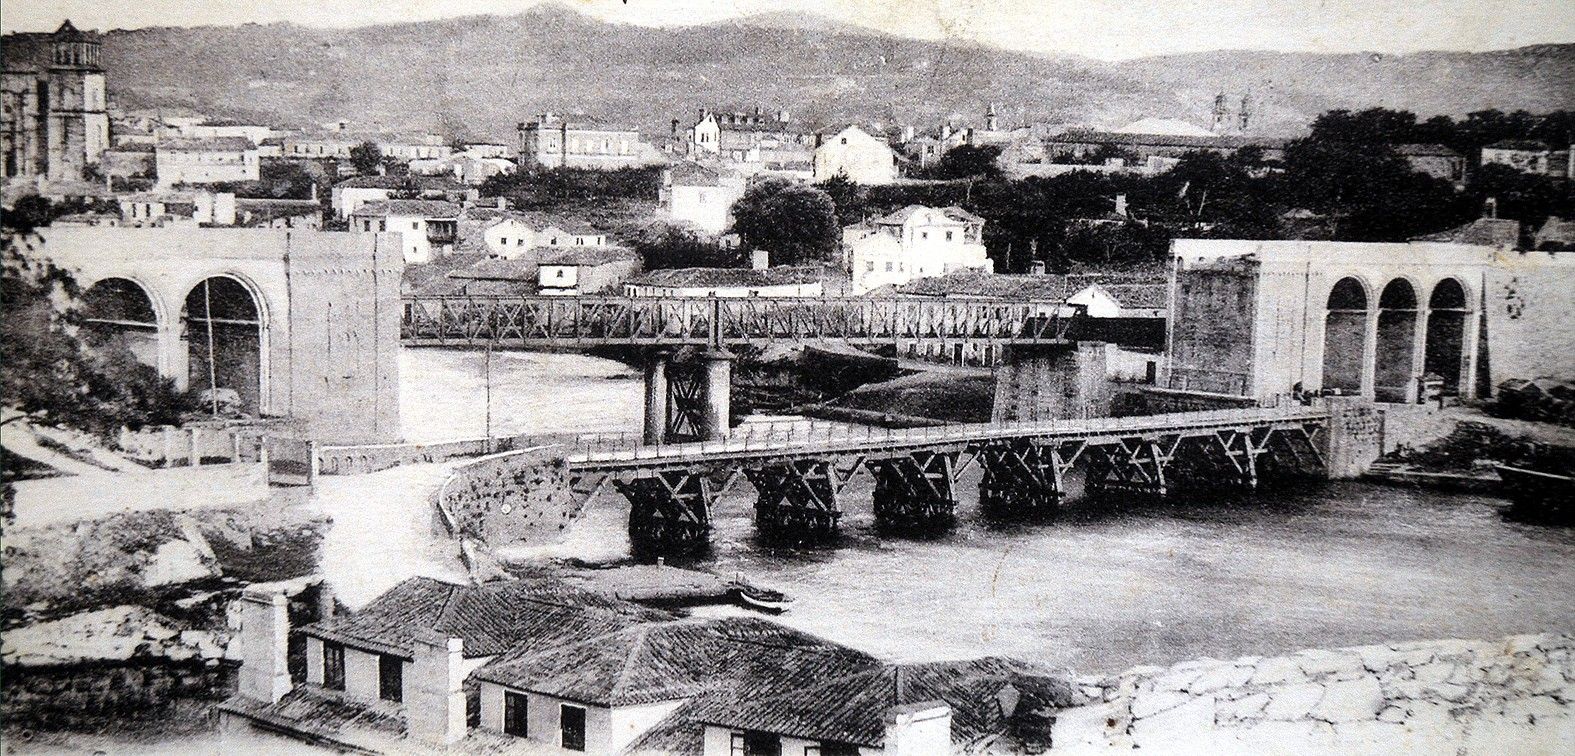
[843,205,995,295]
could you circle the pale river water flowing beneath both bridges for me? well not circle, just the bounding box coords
[402,350,1575,673]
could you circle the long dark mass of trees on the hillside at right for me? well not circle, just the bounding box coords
[821,109,1575,272]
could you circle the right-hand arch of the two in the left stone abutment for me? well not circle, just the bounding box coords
[181,271,269,413]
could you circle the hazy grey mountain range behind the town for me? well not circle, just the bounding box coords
[3,6,1575,139]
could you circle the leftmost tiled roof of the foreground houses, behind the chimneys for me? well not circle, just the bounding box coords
[301,576,669,657]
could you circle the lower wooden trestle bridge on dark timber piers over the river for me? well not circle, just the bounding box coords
[565,406,1331,553]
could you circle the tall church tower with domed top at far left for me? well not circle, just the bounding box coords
[46,20,109,181]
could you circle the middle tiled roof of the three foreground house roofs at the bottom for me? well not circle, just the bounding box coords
[473,617,877,706]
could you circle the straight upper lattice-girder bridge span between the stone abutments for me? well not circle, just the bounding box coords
[400,295,1085,348]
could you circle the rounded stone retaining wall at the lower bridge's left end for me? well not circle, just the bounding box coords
[436,447,583,548]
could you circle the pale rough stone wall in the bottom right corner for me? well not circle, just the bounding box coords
[1051,635,1575,756]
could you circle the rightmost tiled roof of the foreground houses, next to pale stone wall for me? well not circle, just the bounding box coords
[685,657,1073,748]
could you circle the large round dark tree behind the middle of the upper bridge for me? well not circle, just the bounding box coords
[732,178,841,265]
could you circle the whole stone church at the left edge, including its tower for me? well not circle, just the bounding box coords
[0,20,109,181]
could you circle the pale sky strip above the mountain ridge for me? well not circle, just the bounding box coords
[0,0,1575,58]
